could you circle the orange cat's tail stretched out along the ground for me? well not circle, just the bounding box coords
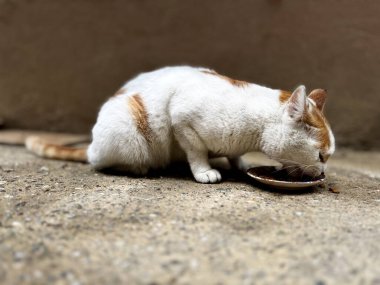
[25,136,87,162]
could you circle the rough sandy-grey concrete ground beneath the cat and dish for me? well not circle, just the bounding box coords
[0,146,380,285]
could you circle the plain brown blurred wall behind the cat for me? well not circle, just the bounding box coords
[0,0,380,148]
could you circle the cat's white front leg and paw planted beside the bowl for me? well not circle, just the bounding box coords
[174,123,222,183]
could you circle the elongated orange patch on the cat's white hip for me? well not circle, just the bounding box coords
[128,94,152,143]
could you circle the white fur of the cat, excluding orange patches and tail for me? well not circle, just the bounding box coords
[88,66,332,183]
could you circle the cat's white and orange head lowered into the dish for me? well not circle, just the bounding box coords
[265,86,335,176]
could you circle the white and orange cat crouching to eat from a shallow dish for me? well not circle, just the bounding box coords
[26,66,335,183]
